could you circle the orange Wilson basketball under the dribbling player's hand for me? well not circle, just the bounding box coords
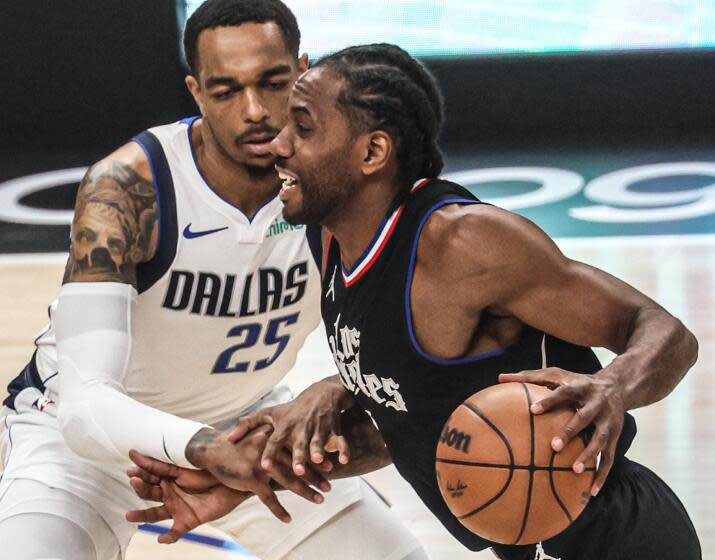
[436,383,596,544]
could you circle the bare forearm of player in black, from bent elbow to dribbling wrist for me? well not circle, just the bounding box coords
[601,306,698,409]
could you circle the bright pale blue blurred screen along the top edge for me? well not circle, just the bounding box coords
[179,0,715,58]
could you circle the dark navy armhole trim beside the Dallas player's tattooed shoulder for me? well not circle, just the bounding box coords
[132,131,178,294]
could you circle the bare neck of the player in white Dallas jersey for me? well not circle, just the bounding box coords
[191,123,281,216]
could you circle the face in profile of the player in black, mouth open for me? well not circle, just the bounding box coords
[272,67,360,224]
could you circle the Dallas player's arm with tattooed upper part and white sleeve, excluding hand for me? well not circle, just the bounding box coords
[52,143,211,467]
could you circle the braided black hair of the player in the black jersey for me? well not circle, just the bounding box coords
[314,43,444,188]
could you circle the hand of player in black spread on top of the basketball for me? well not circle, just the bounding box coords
[499,367,626,496]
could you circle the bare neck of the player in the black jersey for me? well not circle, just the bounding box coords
[324,177,400,269]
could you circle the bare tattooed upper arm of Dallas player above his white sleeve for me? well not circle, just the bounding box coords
[63,160,158,286]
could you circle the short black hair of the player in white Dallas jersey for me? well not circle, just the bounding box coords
[184,0,300,75]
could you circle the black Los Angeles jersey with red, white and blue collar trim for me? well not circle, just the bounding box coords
[321,179,635,550]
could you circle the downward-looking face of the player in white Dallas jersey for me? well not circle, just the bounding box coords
[187,22,307,168]
